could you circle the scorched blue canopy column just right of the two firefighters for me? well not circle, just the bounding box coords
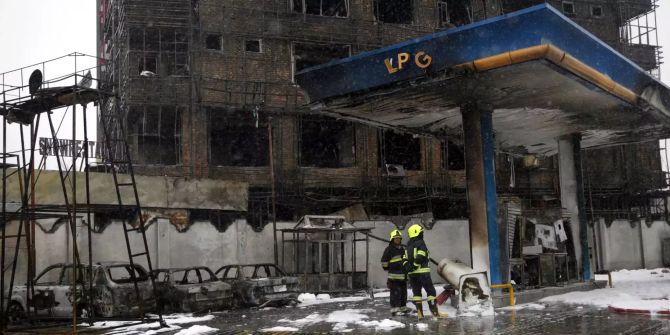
[461,102,501,284]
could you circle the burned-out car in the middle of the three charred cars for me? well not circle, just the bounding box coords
[153,266,234,312]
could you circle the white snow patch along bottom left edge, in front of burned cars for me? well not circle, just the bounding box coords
[82,313,217,335]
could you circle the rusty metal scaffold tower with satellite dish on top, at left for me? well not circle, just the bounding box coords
[0,52,164,333]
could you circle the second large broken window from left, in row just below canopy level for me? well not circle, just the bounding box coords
[209,110,269,166]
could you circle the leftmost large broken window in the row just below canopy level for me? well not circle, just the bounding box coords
[128,105,181,165]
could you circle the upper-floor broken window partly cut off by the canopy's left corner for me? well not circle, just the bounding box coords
[293,43,351,80]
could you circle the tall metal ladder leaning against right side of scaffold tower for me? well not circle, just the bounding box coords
[98,97,166,327]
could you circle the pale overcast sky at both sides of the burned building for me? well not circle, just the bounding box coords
[0,0,670,171]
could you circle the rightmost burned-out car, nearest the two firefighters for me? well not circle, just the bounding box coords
[216,264,299,306]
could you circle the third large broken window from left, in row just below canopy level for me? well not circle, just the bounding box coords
[300,116,356,168]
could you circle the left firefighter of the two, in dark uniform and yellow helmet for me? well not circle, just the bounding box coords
[382,229,409,315]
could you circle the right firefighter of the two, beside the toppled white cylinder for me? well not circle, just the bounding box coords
[403,224,441,319]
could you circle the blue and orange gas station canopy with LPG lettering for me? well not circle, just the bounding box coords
[296,4,670,155]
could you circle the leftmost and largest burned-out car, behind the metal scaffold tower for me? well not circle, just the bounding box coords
[8,262,155,323]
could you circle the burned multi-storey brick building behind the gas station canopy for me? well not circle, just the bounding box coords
[93,0,667,286]
